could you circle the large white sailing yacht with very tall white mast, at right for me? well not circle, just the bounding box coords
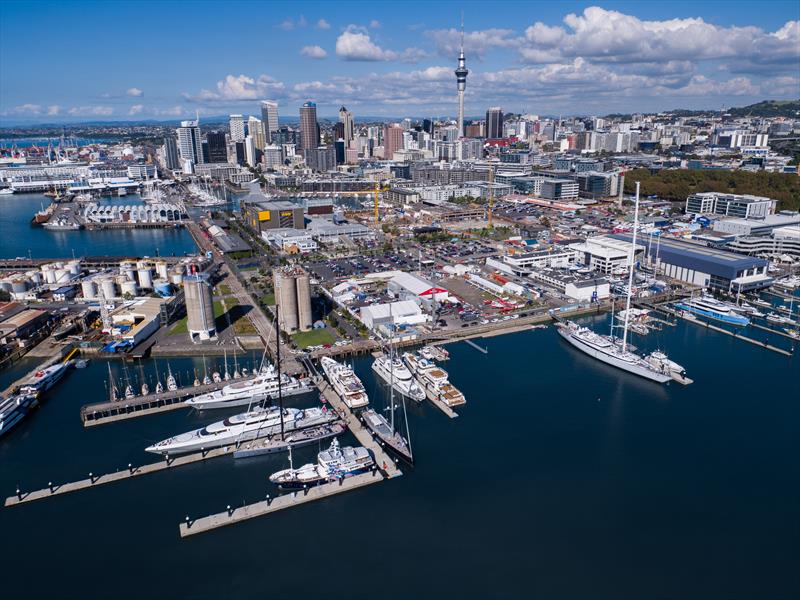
[556,182,686,383]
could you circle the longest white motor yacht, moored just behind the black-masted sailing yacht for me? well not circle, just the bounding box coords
[145,406,339,454]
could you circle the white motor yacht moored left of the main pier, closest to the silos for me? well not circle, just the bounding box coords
[186,365,311,410]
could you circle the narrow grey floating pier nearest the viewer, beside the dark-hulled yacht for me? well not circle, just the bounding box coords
[179,469,385,538]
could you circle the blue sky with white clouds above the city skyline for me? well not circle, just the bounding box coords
[0,0,800,125]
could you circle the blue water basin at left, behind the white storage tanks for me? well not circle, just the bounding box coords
[0,194,197,258]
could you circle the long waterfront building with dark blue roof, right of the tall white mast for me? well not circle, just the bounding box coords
[613,234,773,292]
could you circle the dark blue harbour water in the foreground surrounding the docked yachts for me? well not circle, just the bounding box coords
[0,318,800,600]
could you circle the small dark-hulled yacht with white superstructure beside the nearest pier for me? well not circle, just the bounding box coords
[269,438,375,489]
